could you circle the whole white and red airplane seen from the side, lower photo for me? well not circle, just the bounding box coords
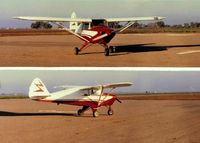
[29,78,132,117]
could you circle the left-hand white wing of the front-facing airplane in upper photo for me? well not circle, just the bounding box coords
[14,16,92,23]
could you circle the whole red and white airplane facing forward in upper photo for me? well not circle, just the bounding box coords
[15,12,164,56]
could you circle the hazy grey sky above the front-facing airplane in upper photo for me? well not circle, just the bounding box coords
[0,0,200,28]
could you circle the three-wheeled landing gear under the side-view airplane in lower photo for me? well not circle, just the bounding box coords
[77,106,114,117]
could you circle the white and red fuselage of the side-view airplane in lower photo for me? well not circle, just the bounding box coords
[33,88,117,109]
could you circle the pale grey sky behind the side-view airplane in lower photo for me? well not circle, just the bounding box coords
[0,68,200,95]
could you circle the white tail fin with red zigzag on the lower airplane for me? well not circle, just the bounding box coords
[29,78,50,99]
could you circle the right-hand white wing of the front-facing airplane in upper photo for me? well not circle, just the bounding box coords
[105,16,165,22]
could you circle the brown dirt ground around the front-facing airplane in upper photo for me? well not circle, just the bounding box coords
[0,33,200,67]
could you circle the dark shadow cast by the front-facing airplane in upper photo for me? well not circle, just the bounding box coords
[80,43,200,56]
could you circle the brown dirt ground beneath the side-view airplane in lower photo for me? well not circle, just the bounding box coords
[0,99,200,143]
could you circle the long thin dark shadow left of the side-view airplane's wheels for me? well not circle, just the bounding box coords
[0,111,77,116]
